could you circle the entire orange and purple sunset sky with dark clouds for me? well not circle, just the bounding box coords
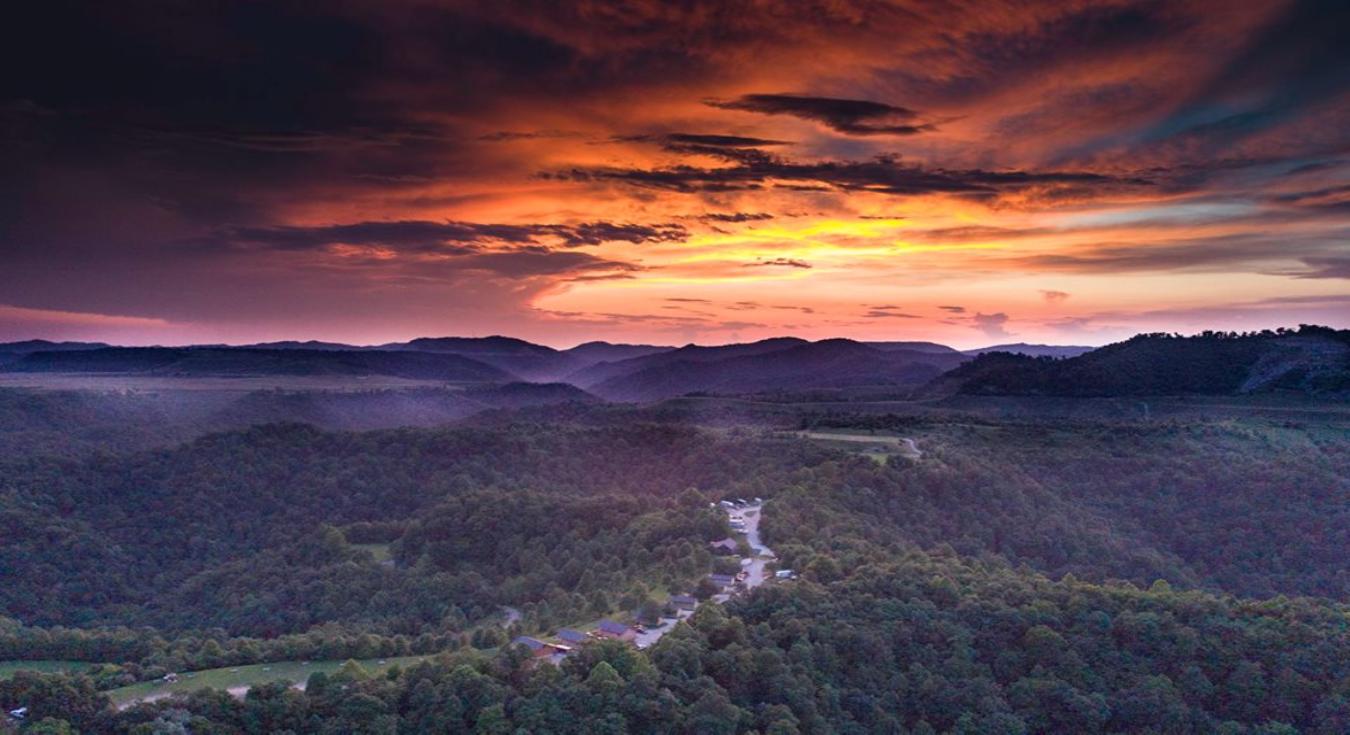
[0,0,1350,347]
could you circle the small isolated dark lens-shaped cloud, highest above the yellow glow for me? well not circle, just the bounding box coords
[707,95,936,135]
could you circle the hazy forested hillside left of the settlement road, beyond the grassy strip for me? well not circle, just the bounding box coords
[0,424,822,635]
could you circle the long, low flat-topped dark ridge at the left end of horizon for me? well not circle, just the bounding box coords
[3,347,514,382]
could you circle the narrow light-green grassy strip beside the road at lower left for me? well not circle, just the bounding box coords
[108,655,429,707]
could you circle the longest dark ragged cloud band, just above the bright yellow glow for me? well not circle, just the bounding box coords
[558,157,1150,197]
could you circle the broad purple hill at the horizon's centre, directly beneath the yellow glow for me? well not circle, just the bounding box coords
[590,339,967,401]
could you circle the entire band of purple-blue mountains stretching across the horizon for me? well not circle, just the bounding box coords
[0,327,1350,405]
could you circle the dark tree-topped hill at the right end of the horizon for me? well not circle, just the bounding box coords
[932,327,1350,396]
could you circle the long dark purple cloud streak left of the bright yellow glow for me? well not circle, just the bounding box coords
[209,220,689,253]
